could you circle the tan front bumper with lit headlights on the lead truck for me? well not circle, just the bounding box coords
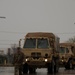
[25,58,52,68]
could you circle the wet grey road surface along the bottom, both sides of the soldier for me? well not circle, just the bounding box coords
[0,67,75,75]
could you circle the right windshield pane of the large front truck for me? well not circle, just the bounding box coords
[37,38,49,48]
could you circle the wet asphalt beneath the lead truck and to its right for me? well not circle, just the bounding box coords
[27,68,75,75]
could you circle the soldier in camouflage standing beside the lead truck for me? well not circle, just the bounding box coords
[13,47,24,75]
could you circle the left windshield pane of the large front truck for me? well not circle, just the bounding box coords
[24,38,36,48]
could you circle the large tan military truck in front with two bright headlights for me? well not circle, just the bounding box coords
[19,32,60,73]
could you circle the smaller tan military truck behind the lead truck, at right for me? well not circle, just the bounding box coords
[59,43,74,69]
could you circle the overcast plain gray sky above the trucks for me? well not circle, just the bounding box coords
[0,0,75,48]
